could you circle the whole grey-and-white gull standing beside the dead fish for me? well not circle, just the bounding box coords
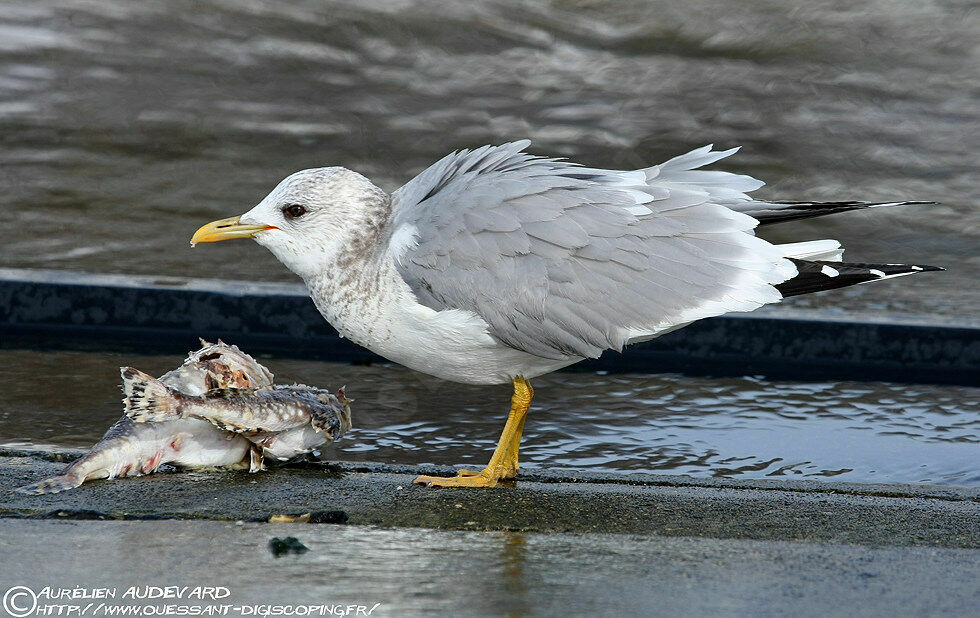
[191,140,942,487]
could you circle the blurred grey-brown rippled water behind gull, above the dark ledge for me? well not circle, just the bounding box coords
[0,0,980,316]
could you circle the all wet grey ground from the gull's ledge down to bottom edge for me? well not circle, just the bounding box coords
[0,452,980,616]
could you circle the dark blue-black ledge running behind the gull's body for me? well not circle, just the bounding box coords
[0,269,980,385]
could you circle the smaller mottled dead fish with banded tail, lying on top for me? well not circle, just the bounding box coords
[121,367,351,444]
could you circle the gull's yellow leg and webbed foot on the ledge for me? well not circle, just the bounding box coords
[415,377,534,487]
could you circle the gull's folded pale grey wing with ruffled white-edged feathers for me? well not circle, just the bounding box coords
[389,141,796,359]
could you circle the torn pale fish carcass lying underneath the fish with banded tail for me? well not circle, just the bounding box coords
[16,340,274,494]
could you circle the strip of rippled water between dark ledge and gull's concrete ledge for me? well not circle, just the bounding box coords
[0,351,980,486]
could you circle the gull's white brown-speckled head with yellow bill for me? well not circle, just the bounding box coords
[191,167,390,279]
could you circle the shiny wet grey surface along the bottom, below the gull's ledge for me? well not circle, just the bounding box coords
[0,516,980,618]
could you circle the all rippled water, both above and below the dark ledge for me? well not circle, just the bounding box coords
[0,0,980,486]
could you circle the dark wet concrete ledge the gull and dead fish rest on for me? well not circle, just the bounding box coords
[0,450,980,548]
